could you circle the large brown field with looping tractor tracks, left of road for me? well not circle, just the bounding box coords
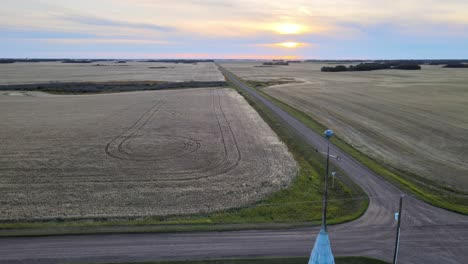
[0,88,297,220]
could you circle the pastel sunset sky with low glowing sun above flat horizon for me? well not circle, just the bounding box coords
[0,0,468,59]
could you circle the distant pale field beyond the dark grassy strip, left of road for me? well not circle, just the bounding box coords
[0,61,224,85]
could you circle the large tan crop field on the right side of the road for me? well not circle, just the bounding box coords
[222,62,468,192]
